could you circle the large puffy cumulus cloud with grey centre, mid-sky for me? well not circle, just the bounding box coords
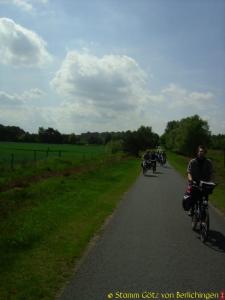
[51,51,148,113]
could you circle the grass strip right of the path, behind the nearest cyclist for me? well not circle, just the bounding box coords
[167,150,225,215]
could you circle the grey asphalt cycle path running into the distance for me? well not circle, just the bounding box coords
[60,166,225,300]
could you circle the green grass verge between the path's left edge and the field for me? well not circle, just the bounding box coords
[0,158,140,300]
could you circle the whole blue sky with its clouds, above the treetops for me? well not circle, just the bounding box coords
[0,0,225,134]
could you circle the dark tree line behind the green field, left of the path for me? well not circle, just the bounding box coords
[0,125,159,156]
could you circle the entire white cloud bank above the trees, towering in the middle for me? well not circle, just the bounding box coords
[0,46,223,133]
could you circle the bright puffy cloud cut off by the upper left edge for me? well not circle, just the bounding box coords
[0,18,51,67]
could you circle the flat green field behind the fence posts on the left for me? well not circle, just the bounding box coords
[0,142,110,190]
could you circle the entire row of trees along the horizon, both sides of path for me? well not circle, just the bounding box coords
[0,115,225,156]
